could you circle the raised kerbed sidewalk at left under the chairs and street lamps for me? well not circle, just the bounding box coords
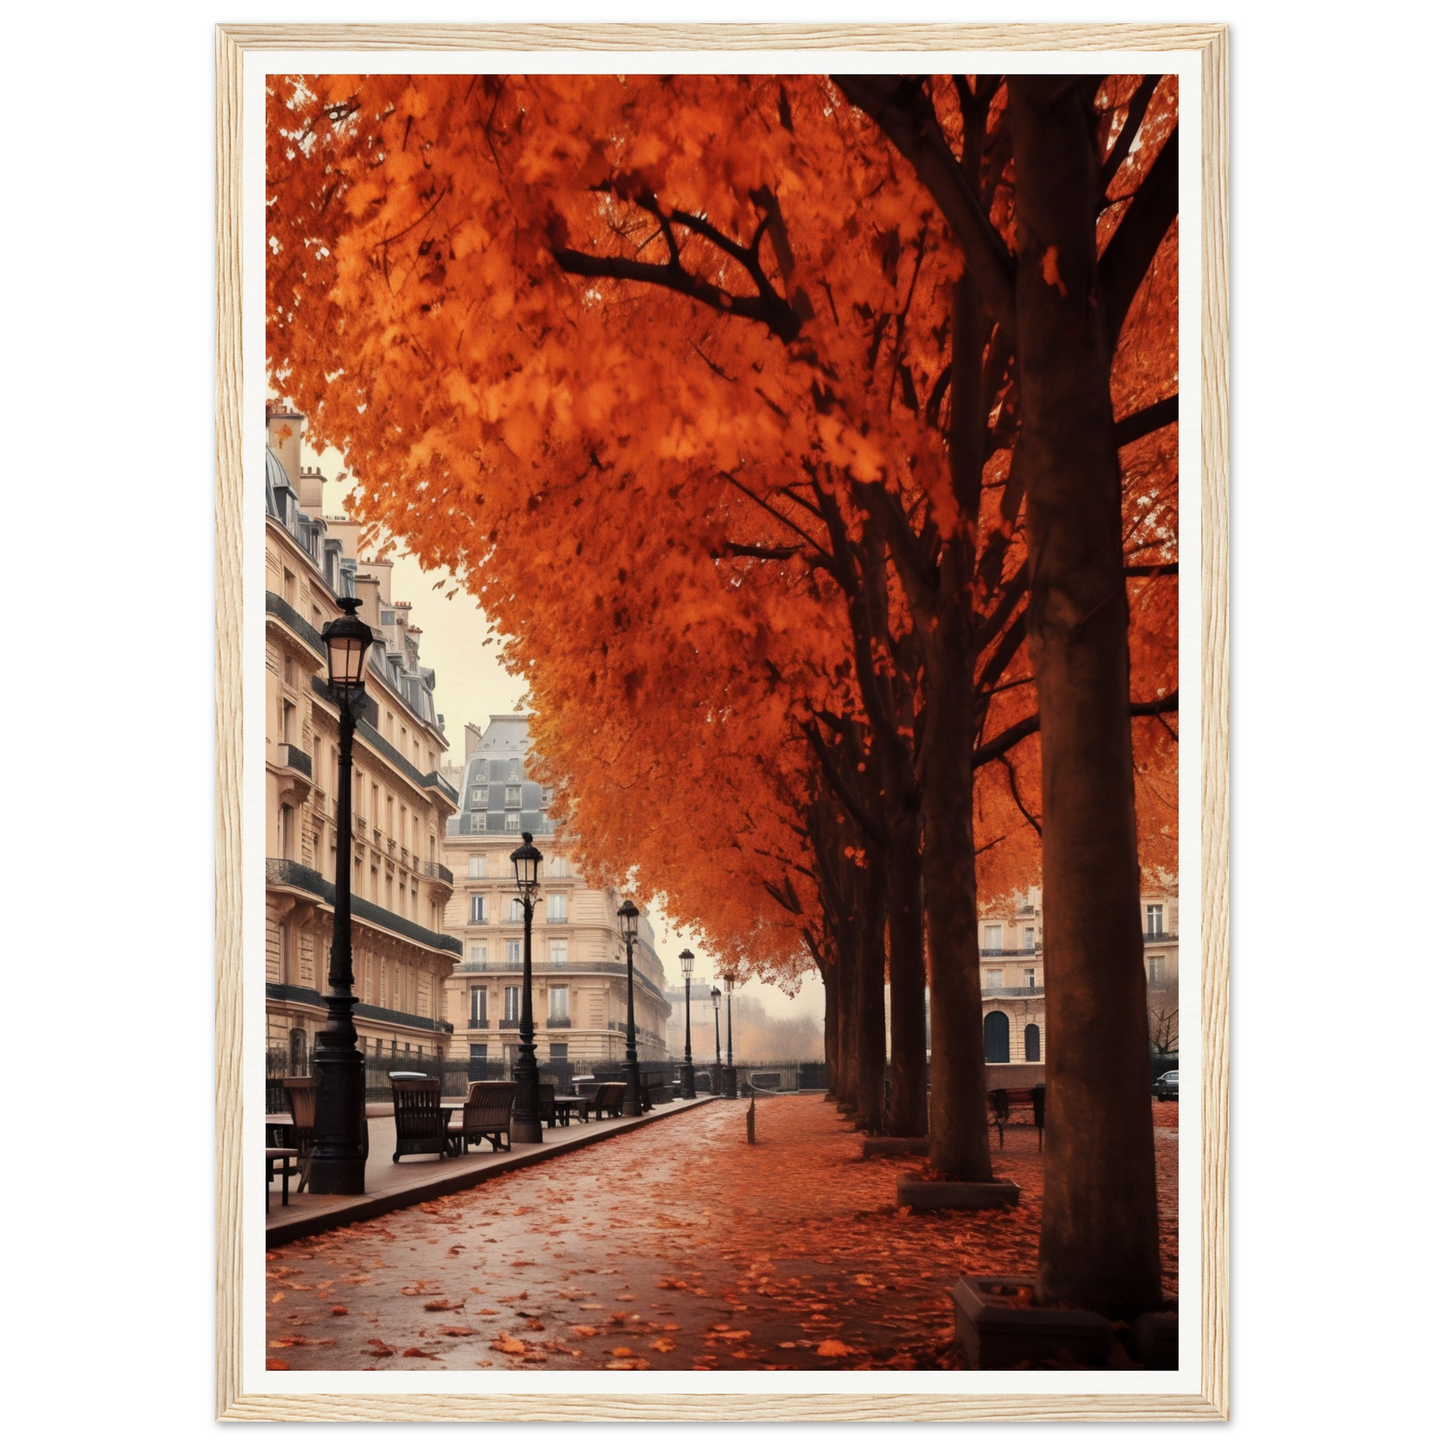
[266,1094,720,1248]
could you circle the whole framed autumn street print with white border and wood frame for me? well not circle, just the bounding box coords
[208,17,1243,1435]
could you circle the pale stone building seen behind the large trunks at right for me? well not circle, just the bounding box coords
[978,887,1179,1084]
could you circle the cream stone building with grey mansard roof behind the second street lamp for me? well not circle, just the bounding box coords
[444,714,670,1072]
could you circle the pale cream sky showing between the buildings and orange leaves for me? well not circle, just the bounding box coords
[317,441,824,1026]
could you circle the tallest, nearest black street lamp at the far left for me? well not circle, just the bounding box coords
[309,597,374,1194]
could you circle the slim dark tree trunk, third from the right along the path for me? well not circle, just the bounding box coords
[887,815,928,1139]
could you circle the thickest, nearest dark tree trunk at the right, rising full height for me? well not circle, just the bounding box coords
[1009,75,1160,1319]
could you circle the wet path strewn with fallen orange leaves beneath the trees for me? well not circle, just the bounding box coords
[266,1095,1178,1370]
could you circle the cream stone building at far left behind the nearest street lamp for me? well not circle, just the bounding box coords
[266,406,461,1074]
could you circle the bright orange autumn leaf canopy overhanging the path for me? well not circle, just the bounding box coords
[267,75,1178,985]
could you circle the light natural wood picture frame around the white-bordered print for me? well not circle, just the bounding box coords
[208,17,1243,1435]
